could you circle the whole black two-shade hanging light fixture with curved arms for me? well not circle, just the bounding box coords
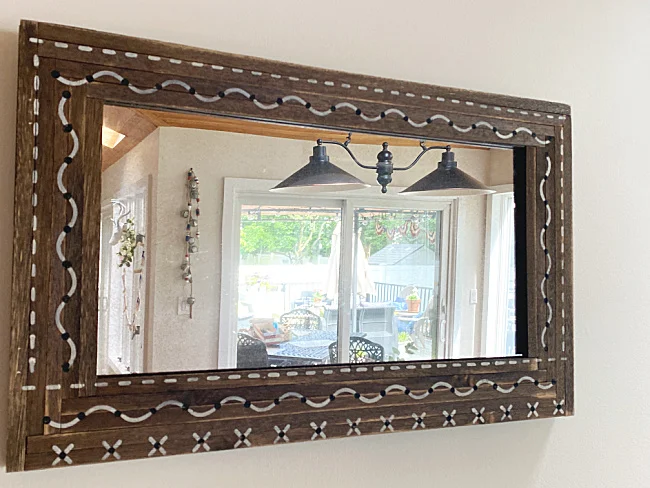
[272,134,494,196]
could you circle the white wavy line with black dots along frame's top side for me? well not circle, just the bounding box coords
[57,70,551,145]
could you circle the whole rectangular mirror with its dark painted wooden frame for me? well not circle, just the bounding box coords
[8,22,573,471]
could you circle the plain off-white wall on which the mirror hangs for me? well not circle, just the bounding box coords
[0,0,650,488]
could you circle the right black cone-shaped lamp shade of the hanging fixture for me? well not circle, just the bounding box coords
[400,150,494,196]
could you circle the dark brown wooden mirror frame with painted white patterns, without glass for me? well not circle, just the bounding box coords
[7,21,573,471]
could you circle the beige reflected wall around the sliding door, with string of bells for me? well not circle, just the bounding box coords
[148,127,492,372]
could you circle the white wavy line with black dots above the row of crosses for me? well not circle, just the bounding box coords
[47,376,555,429]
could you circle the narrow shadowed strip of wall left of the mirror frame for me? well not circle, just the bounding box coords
[0,31,18,467]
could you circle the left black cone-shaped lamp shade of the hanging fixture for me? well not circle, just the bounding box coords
[271,144,370,193]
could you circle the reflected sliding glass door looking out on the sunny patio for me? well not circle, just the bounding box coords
[219,181,451,368]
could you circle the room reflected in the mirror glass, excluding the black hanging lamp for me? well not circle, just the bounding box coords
[97,106,526,375]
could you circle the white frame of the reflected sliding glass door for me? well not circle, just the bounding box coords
[217,178,458,369]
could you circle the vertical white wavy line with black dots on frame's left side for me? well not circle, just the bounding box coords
[54,95,79,369]
